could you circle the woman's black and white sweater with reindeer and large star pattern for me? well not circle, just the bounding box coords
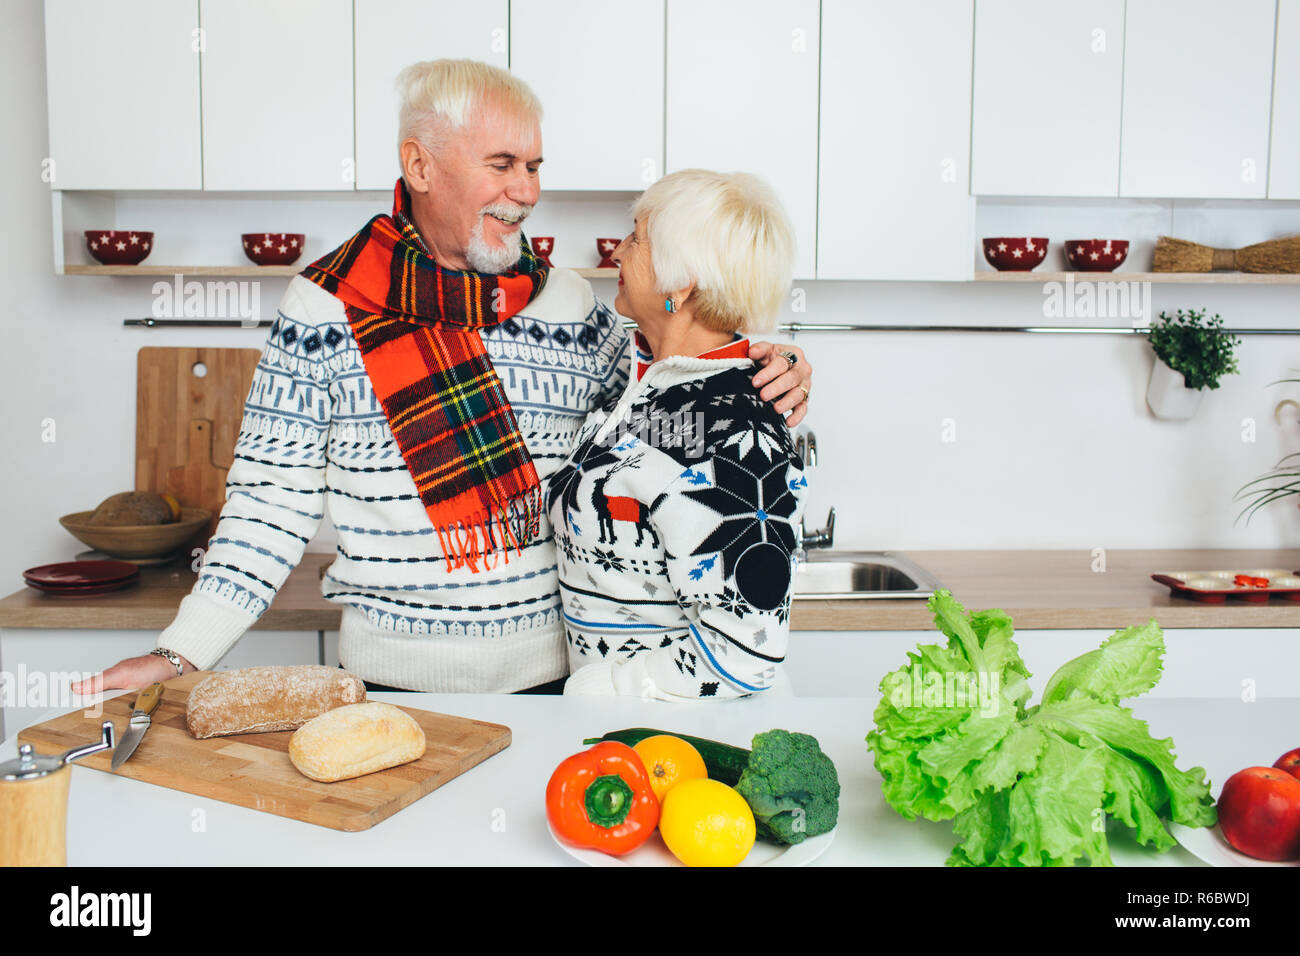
[547,336,807,700]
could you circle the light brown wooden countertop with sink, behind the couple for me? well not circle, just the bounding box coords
[0,549,1300,631]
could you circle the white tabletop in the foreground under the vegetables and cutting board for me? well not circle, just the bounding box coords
[0,693,1300,866]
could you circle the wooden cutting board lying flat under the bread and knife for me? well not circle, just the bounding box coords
[18,671,511,830]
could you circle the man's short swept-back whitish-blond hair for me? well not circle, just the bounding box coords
[397,60,542,162]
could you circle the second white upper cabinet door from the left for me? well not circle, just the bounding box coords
[202,0,356,191]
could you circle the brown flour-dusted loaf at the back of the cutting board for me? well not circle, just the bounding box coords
[185,663,365,737]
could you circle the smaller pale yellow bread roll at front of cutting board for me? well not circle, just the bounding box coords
[289,701,424,783]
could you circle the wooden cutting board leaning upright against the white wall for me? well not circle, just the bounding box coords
[135,346,261,542]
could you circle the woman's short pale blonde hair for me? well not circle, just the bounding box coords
[632,169,794,332]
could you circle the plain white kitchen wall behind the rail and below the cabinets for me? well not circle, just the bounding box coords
[0,0,1300,593]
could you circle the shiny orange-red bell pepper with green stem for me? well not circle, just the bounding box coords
[546,740,659,856]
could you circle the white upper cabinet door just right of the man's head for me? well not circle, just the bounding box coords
[510,0,664,190]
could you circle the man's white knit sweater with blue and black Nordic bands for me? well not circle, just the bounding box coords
[159,269,629,692]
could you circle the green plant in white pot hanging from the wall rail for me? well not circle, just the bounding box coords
[1147,308,1242,420]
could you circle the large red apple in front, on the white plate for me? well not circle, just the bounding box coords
[1218,767,1300,862]
